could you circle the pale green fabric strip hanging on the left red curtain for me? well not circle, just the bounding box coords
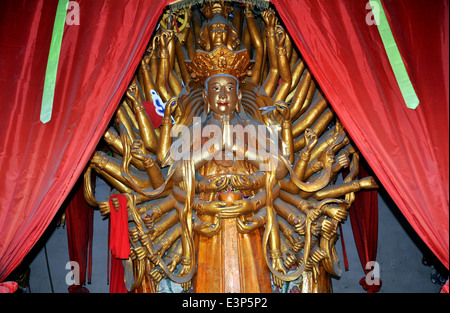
[41,0,69,124]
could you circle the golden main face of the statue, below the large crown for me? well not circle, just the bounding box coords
[203,74,242,115]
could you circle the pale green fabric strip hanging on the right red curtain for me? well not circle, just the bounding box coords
[370,0,419,109]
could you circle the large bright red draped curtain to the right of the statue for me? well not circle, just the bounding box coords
[272,0,449,268]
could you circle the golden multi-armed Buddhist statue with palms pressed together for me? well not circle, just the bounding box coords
[85,1,377,292]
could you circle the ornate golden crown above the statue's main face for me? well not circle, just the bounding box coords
[185,45,254,83]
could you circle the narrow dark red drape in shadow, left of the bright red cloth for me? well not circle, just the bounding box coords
[65,179,94,292]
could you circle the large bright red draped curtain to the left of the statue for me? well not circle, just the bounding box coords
[0,0,168,281]
